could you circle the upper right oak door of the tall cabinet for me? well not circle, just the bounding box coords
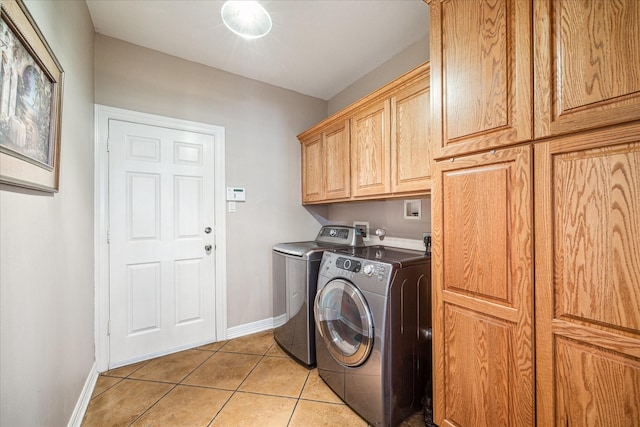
[534,0,640,138]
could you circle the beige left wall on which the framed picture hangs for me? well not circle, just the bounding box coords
[0,0,94,427]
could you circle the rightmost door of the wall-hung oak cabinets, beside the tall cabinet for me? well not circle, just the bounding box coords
[391,74,433,193]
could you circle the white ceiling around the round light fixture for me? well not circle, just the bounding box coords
[87,0,429,100]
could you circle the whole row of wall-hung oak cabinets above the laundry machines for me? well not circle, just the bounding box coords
[298,63,433,204]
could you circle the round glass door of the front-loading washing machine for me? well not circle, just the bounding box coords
[313,279,374,367]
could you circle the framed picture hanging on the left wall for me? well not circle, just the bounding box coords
[0,0,64,193]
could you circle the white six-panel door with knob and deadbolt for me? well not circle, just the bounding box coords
[109,120,216,367]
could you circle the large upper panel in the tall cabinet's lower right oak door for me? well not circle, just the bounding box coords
[553,144,640,331]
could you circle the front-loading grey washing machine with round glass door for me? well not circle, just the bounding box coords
[314,246,432,427]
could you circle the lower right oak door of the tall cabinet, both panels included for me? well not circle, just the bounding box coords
[535,122,640,427]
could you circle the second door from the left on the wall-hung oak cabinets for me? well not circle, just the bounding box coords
[323,120,351,200]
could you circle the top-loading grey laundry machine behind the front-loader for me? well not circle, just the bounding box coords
[272,225,364,367]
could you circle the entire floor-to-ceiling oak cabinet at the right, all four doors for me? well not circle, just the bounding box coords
[425,0,640,427]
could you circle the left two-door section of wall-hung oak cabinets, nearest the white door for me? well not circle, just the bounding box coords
[301,120,351,204]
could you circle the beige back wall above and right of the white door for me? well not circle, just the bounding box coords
[95,35,327,328]
